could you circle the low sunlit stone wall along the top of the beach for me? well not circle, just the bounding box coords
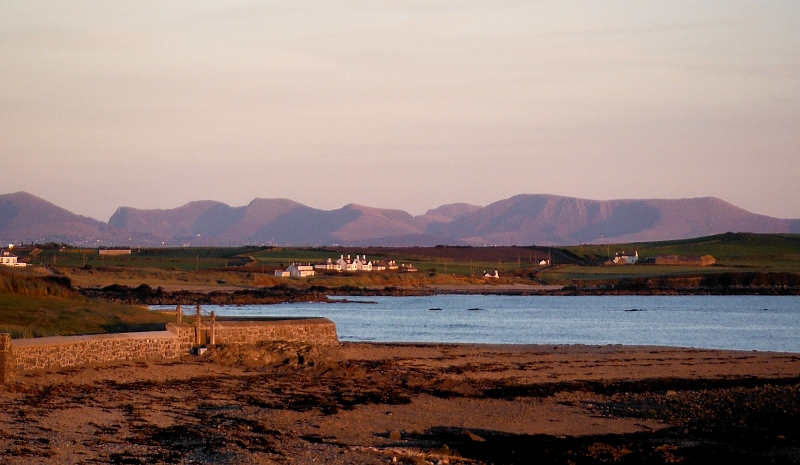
[0,318,339,382]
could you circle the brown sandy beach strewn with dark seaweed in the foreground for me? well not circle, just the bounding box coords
[0,343,800,464]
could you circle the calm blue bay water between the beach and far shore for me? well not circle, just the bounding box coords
[156,295,800,353]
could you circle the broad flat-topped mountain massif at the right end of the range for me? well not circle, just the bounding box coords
[429,195,800,245]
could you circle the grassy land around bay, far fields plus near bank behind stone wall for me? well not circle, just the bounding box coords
[0,234,800,337]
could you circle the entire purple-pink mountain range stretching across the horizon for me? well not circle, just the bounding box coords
[0,192,800,247]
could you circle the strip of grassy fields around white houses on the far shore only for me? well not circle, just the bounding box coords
[10,233,800,290]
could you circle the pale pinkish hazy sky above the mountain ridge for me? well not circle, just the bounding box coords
[0,0,800,221]
